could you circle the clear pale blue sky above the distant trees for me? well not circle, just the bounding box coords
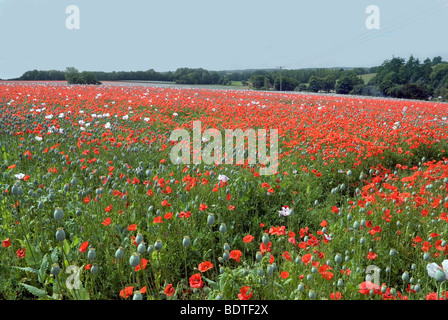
[0,0,448,79]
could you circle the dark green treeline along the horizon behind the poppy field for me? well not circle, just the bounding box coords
[14,56,448,100]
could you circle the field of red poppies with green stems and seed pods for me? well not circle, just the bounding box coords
[0,82,448,300]
